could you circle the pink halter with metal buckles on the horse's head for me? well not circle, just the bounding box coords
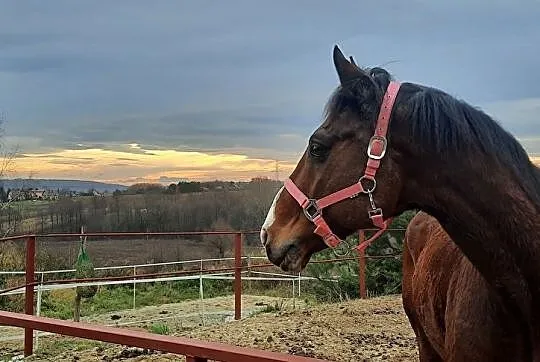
[285,81,400,251]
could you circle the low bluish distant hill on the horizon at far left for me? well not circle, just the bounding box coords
[0,179,128,192]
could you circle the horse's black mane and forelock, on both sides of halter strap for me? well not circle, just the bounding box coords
[324,67,540,205]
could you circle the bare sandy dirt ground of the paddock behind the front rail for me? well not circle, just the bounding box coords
[0,295,418,362]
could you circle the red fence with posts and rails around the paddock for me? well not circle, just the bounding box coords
[0,231,402,361]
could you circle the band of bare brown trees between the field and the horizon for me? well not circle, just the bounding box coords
[0,179,282,240]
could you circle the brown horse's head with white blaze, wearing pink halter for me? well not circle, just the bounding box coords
[261,46,403,272]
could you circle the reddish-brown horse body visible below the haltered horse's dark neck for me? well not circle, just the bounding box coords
[402,212,523,361]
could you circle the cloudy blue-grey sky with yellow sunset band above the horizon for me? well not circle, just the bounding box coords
[0,0,540,185]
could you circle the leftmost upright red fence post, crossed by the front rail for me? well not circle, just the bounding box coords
[24,236,36,357]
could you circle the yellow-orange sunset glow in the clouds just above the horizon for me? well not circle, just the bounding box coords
[10,144,294,185]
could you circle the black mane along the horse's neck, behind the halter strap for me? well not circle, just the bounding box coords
[407,85,540,205]
